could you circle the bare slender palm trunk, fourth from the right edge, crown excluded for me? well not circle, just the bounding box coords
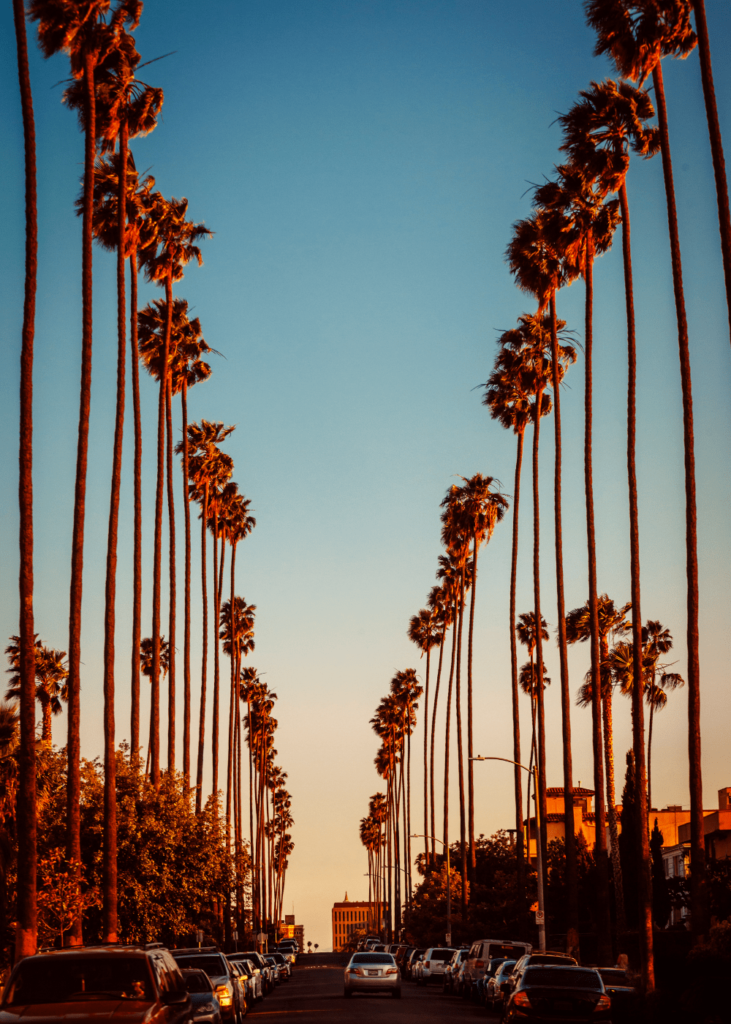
[584,238,611,964]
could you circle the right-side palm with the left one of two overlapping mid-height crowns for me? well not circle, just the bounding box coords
[482,338,532,893]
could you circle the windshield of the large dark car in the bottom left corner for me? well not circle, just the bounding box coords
[3,956,155,1007]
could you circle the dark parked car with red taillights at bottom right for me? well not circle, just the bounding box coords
[503,965,611,1024]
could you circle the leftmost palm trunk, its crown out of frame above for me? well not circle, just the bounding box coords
[12,0,38,961]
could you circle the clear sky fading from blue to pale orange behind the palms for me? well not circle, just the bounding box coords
[0,0,731,948]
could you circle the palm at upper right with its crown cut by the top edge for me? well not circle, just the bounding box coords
[586,0,708,942]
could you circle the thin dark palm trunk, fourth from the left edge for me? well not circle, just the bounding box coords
[129,250,142,764]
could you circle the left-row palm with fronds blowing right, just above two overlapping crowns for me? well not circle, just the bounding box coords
[143,199,212,786]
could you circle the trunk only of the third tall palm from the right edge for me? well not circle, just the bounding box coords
[619,183,655,992]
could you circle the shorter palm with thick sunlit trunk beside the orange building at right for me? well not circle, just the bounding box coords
[566,594,632,933]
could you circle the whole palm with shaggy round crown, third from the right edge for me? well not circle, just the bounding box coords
[559,70,659,961]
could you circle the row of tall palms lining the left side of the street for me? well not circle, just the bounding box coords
[12,0,292,956]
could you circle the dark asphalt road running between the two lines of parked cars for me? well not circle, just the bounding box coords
[249,953,490,1024]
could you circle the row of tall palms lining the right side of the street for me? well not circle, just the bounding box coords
[352,0,731,992]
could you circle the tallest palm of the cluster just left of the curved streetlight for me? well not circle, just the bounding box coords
[446,473,508,882]
